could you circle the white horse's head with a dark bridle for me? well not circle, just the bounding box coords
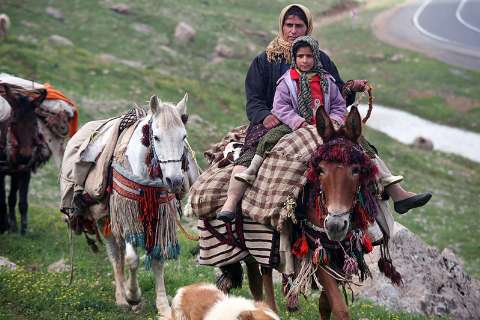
[150,94,188,191]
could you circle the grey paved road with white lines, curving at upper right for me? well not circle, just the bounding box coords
[373,0,480,70]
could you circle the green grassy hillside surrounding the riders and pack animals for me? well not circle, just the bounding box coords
[0,0,480,319]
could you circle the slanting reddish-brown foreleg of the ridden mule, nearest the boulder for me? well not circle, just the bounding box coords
[317,268,350,320]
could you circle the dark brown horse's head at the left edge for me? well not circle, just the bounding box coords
[4,84,47,164]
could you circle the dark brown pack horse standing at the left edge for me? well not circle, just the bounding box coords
[0,83,51,234]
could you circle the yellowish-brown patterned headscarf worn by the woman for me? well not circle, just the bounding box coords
[265,4,313,63]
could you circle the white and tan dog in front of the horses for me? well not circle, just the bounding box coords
[172,283,280,320]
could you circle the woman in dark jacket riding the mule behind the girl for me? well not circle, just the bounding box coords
[217,4,431,221]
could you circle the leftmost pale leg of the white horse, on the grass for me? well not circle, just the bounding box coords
[105,235,129,306]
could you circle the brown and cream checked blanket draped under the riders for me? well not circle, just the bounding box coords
[190,126,322,231]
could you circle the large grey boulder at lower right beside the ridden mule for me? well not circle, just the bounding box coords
[355,223,480,319]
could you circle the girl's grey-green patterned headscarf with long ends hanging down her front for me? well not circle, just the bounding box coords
[291,36,328,123]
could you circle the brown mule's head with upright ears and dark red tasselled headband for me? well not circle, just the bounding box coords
[308,107,377,241]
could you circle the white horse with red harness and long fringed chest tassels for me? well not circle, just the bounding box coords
[64,94,199,318]
